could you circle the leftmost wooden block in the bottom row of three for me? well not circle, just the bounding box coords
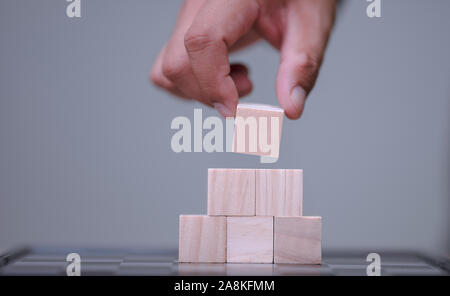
[178,215,227,263]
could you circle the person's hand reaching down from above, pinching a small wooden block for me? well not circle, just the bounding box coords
[150,0,336,119]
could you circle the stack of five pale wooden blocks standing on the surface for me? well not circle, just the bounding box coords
[179,169,322,264]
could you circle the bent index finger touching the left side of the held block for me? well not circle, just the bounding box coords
[184,0,258,117]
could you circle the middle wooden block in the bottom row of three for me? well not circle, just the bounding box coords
[227,216,273,263]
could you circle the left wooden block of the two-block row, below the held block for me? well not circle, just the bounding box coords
[208,169,256,216]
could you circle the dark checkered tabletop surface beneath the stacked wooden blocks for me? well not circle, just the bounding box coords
[0,249,450,276]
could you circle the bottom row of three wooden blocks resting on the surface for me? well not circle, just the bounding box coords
[178,215,322,264]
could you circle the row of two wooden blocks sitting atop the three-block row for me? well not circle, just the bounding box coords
[208,169,303,216]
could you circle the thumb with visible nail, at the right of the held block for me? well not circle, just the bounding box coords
[276,0,335,119]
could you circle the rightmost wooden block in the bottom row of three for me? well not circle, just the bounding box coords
[274,217,322,264]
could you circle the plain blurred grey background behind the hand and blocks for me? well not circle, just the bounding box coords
[0,0,450,255]
